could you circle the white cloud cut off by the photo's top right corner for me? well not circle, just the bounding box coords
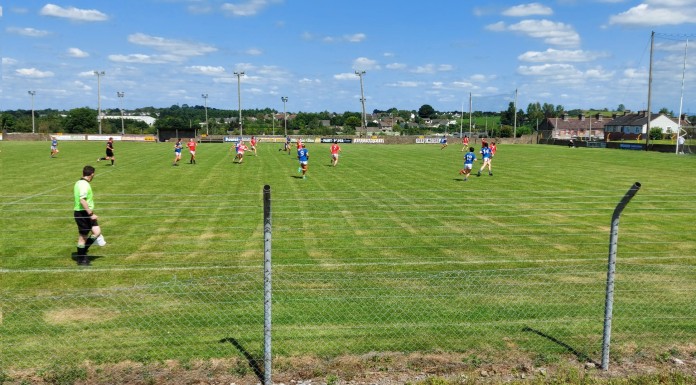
[609,0,696,27]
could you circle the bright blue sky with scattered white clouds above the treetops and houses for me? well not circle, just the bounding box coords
[0,0,696,114]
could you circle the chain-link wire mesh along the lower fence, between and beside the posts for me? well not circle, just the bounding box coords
[0,263,696,368]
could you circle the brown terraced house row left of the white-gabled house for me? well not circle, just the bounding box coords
[539,113,609,139]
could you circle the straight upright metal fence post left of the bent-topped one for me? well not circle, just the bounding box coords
[263,185,273,385]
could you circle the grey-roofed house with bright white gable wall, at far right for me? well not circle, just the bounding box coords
[605,111,690,139]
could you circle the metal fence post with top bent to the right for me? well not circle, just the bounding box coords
[602,182,640,370]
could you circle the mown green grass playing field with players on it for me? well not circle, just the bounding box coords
[0,142,696,374]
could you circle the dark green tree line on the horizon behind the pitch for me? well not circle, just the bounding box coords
[0,102,694,137]
